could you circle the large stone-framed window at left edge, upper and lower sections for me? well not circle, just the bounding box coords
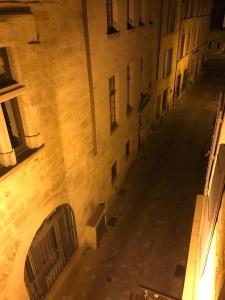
[0,48,42,172]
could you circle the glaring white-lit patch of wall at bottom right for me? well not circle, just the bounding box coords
[197,230,216,300]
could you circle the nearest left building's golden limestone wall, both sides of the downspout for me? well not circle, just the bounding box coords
[0,0,160,300]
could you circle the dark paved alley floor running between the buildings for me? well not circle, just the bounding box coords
[50,79,223,300]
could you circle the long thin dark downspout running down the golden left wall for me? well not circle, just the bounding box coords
[82,0,97,155]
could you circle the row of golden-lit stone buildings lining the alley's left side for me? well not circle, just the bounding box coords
[0,0,211,300]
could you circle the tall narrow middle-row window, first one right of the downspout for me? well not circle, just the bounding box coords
[109,76,118,133]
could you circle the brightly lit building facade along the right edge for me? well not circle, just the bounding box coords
[183,92,225,300]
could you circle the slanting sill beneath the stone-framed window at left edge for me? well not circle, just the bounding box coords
[0,144,44,181]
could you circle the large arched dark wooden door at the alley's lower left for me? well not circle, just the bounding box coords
[24,204,77,300]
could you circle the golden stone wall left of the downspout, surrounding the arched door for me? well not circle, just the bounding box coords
[0,1,98,300]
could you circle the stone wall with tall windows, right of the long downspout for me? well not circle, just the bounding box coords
[87,0,160,200]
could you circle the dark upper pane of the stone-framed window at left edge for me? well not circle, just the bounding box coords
[0,48,16,88]
